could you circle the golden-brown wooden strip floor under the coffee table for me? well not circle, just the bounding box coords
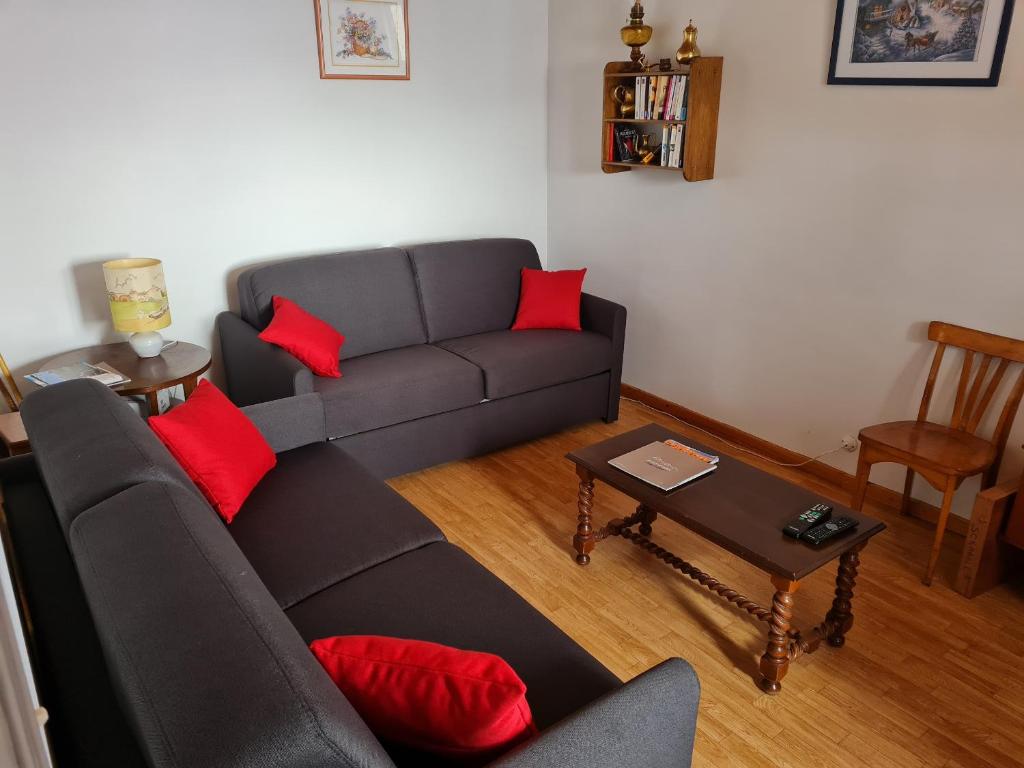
[392,402,1024,768]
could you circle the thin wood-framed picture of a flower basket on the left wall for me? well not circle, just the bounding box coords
[313,0,409,80]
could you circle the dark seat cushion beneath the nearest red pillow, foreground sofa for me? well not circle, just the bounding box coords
[287,544,621,741]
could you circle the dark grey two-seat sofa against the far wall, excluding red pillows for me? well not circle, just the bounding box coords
[217,240,626,477]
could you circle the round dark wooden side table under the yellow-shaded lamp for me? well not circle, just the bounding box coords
[39,341,210,415]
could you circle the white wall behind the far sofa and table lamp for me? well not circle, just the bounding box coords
[0,0,548,385]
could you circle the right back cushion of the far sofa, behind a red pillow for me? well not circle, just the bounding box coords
[409,240,541,342]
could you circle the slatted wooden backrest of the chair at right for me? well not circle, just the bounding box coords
[918,322,1024,454]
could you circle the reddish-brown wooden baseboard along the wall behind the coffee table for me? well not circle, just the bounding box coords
[622,384,969,536]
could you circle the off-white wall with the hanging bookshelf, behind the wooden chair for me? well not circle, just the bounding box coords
[548,0,1024,512]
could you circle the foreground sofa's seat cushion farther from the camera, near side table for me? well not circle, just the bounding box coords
[228,442,444,608]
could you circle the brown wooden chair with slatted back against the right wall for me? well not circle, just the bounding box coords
[853,323,1024,585]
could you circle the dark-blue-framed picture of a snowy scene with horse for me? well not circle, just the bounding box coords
[828,0,1014,86]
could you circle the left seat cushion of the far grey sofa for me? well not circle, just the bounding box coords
[313,344,483,438]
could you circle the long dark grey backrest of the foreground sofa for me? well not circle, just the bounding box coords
[23,381,393,768]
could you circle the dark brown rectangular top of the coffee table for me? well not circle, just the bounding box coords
[566,424,886,581]
